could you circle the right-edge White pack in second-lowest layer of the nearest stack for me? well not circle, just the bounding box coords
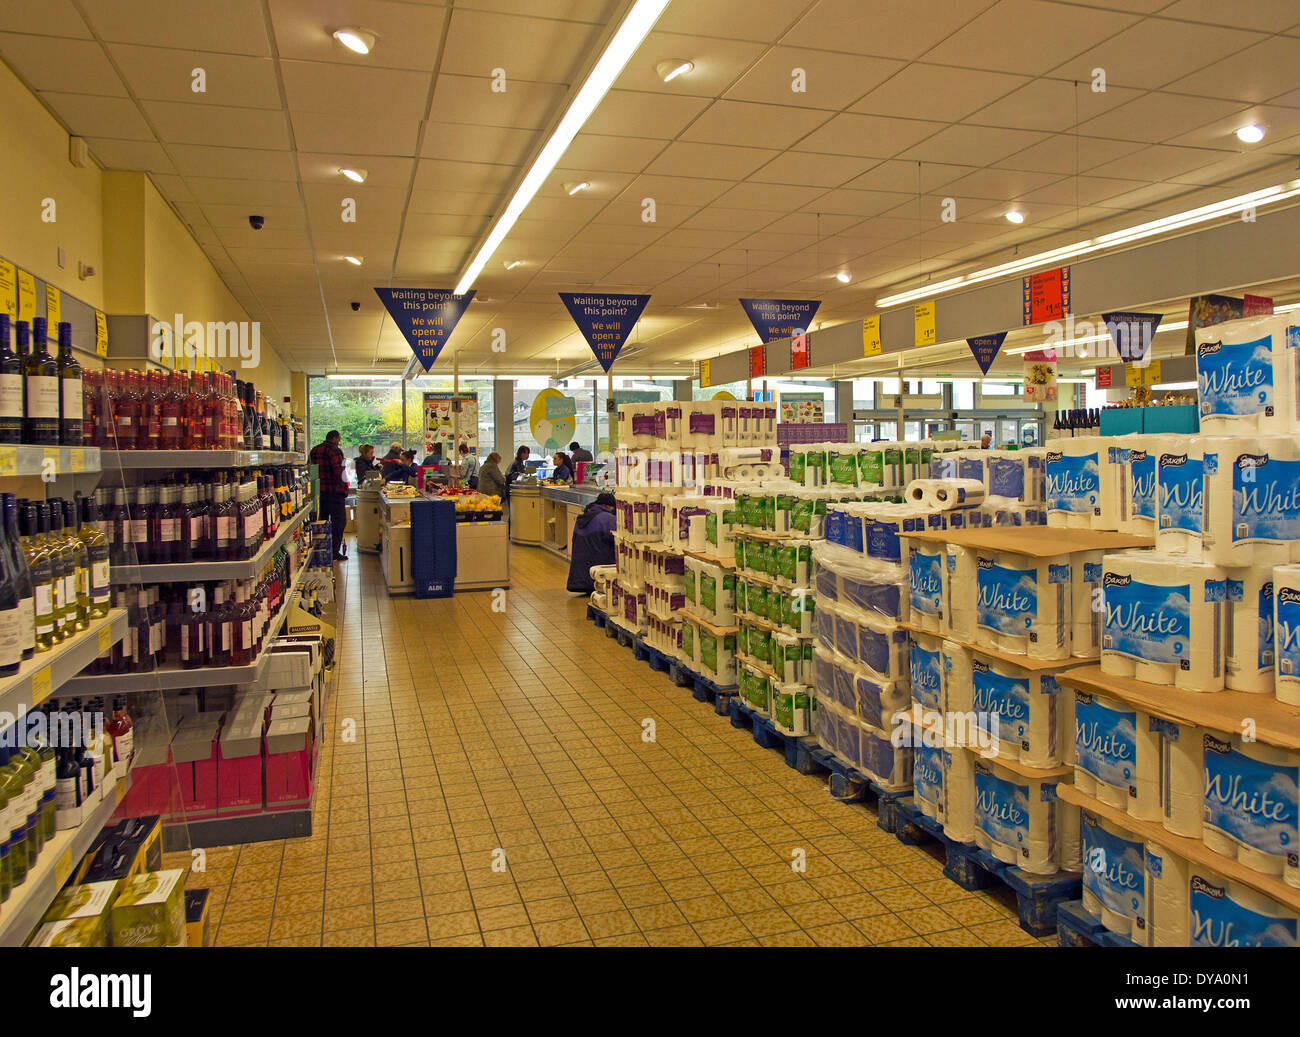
[1201,734,1300,886]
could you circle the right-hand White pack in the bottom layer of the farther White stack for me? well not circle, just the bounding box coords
[974,760,1060,875]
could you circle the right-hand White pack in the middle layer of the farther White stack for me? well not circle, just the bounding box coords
[971,651,1074,768]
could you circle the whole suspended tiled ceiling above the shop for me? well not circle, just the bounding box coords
[0,0,1300,374]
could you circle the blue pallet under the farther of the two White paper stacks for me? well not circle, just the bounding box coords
[894,797,1083,936]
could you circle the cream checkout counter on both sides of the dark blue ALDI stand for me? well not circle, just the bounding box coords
[379,491,510,595]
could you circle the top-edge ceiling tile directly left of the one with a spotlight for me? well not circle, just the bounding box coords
[79,0,270,57]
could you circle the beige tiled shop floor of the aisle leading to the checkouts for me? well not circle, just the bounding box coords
[165,547,1056,947]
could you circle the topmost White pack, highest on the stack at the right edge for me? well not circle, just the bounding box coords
[1196,316,1300,435]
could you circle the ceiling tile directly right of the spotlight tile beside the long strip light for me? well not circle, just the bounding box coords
[727,47,904,116]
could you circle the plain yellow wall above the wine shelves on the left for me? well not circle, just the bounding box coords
[0,62,295,404]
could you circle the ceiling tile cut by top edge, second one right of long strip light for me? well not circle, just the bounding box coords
[781,0,995,61]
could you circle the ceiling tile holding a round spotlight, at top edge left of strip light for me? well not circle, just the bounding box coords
[268,0,449,74]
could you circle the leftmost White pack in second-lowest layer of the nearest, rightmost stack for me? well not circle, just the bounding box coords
[1074,690,1161,821]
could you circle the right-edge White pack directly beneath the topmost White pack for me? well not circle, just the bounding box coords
[1204,437,1300,567]
